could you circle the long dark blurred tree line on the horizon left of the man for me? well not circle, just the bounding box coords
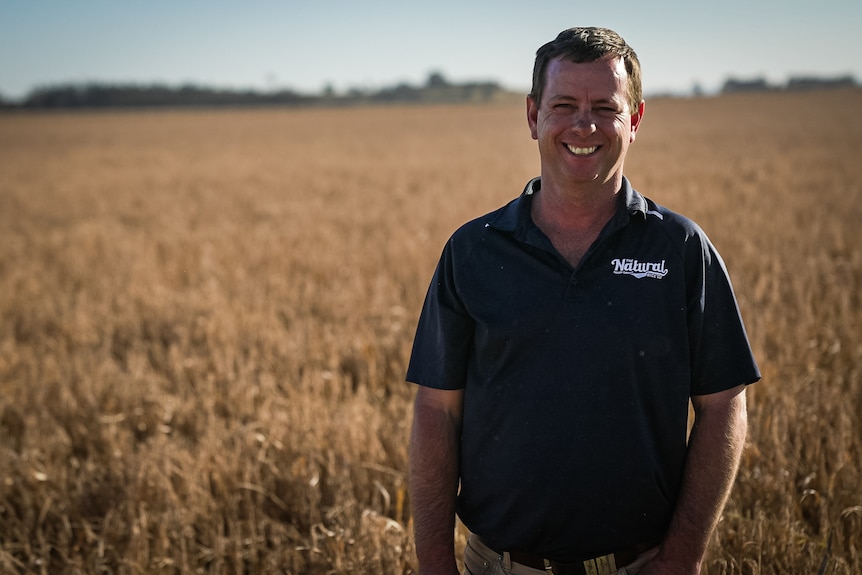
[0,72,507,109]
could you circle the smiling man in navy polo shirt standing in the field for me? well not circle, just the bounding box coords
[407,28,760,575]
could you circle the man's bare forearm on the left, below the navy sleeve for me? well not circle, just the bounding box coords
[410,386,464,575]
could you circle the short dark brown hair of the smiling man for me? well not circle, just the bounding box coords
[530,28,643,111]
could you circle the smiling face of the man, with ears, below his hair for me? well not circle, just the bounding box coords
[527,58,644,191]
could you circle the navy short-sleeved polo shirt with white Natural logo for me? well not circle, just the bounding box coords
[407,178,760,561]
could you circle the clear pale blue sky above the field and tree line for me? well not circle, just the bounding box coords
[0,0,862,100]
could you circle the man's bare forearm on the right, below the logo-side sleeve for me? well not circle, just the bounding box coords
[640,385,748,575]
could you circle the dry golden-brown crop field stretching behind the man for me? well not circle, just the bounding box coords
[0,90,862,575]
